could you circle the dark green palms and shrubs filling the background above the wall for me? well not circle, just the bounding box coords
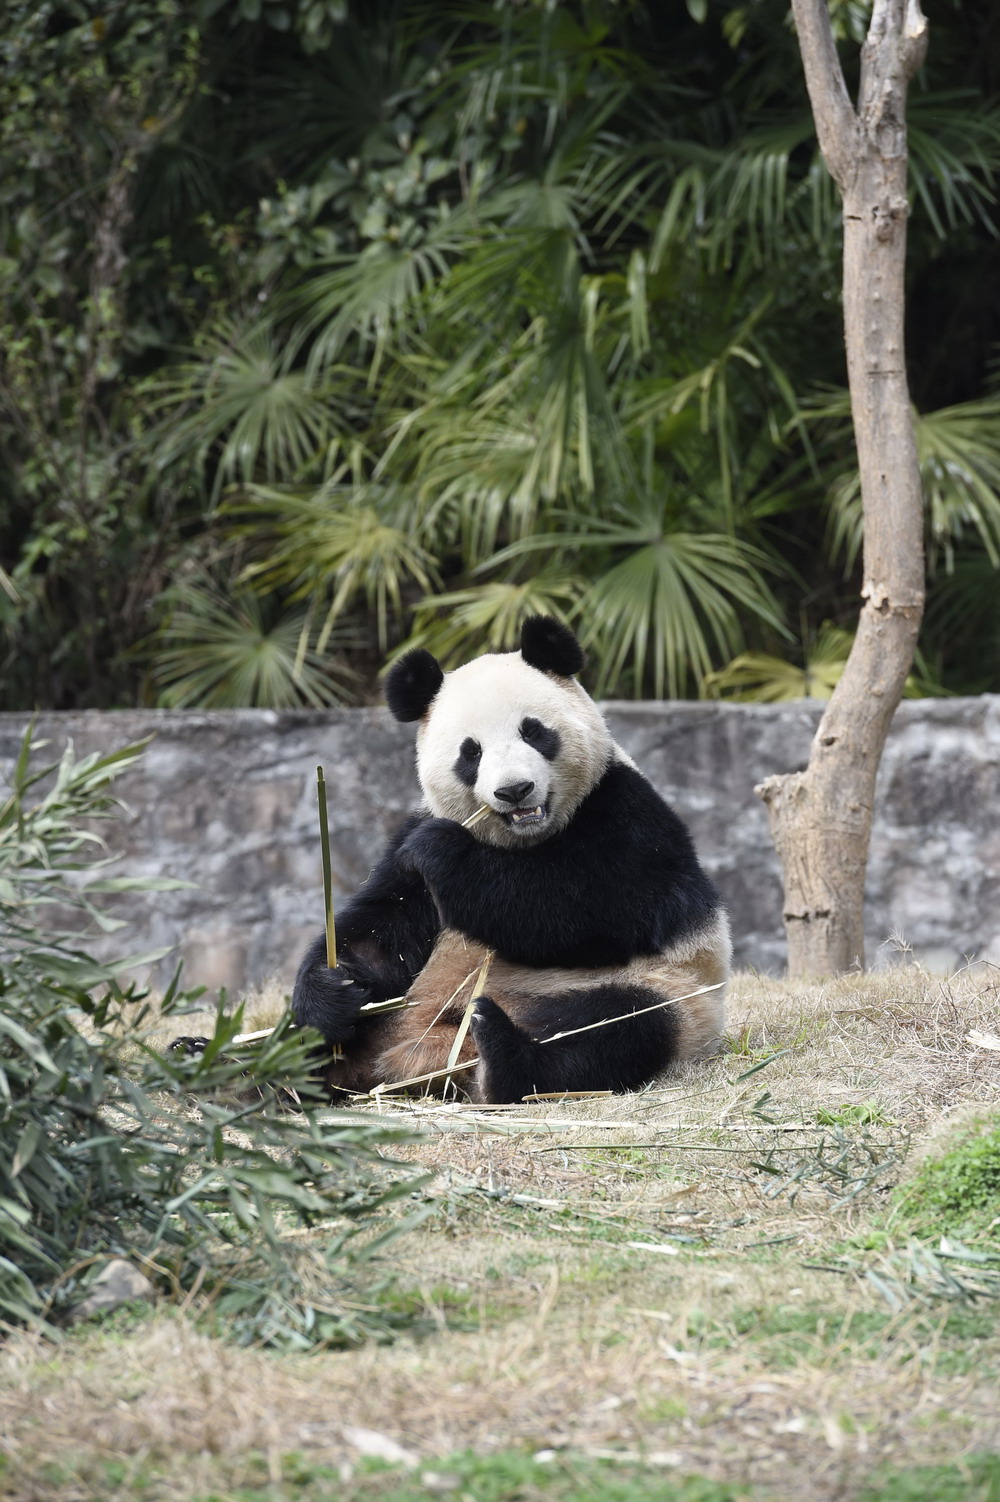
[0,0,1000,709]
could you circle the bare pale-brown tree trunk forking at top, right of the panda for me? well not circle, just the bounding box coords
[757,0,926,976]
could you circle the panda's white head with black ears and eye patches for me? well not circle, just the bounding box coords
[386,616,616,847]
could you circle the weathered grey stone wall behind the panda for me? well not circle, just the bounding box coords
[0,695,1000,990]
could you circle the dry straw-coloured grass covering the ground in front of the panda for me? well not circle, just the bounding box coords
[0,966,1000,1502]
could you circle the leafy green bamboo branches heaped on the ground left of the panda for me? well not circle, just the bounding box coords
[0,723,425,1349]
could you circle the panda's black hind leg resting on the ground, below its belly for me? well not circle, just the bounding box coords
[471,985,679,1105]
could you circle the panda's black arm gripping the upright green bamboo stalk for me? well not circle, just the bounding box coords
[291,814,440,1042]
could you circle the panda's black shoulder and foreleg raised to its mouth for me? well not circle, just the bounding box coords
[396,763,719,967]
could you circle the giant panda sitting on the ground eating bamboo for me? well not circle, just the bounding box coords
[291,616,731,1104]
